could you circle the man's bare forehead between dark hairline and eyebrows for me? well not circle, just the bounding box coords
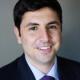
[22,7,59,23]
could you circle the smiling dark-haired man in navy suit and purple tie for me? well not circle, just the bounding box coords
[0,0,80,80]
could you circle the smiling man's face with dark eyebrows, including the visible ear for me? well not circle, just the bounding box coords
[14,8,61,64]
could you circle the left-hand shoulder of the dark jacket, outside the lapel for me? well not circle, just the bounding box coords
[0,57,20,80]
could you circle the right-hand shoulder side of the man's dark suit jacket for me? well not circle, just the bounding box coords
[57,57,80,80]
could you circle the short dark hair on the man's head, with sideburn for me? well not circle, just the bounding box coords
[13,0,62,29]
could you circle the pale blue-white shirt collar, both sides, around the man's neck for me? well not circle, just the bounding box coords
[25,56,58,80]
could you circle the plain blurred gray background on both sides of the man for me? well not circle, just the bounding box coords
[0,0,80,67]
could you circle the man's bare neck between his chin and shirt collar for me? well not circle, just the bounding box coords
[26,56,55,74]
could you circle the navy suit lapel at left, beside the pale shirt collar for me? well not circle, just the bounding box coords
[18,55,35,80]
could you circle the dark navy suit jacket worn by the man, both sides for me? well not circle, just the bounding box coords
[0,55,80,80]
